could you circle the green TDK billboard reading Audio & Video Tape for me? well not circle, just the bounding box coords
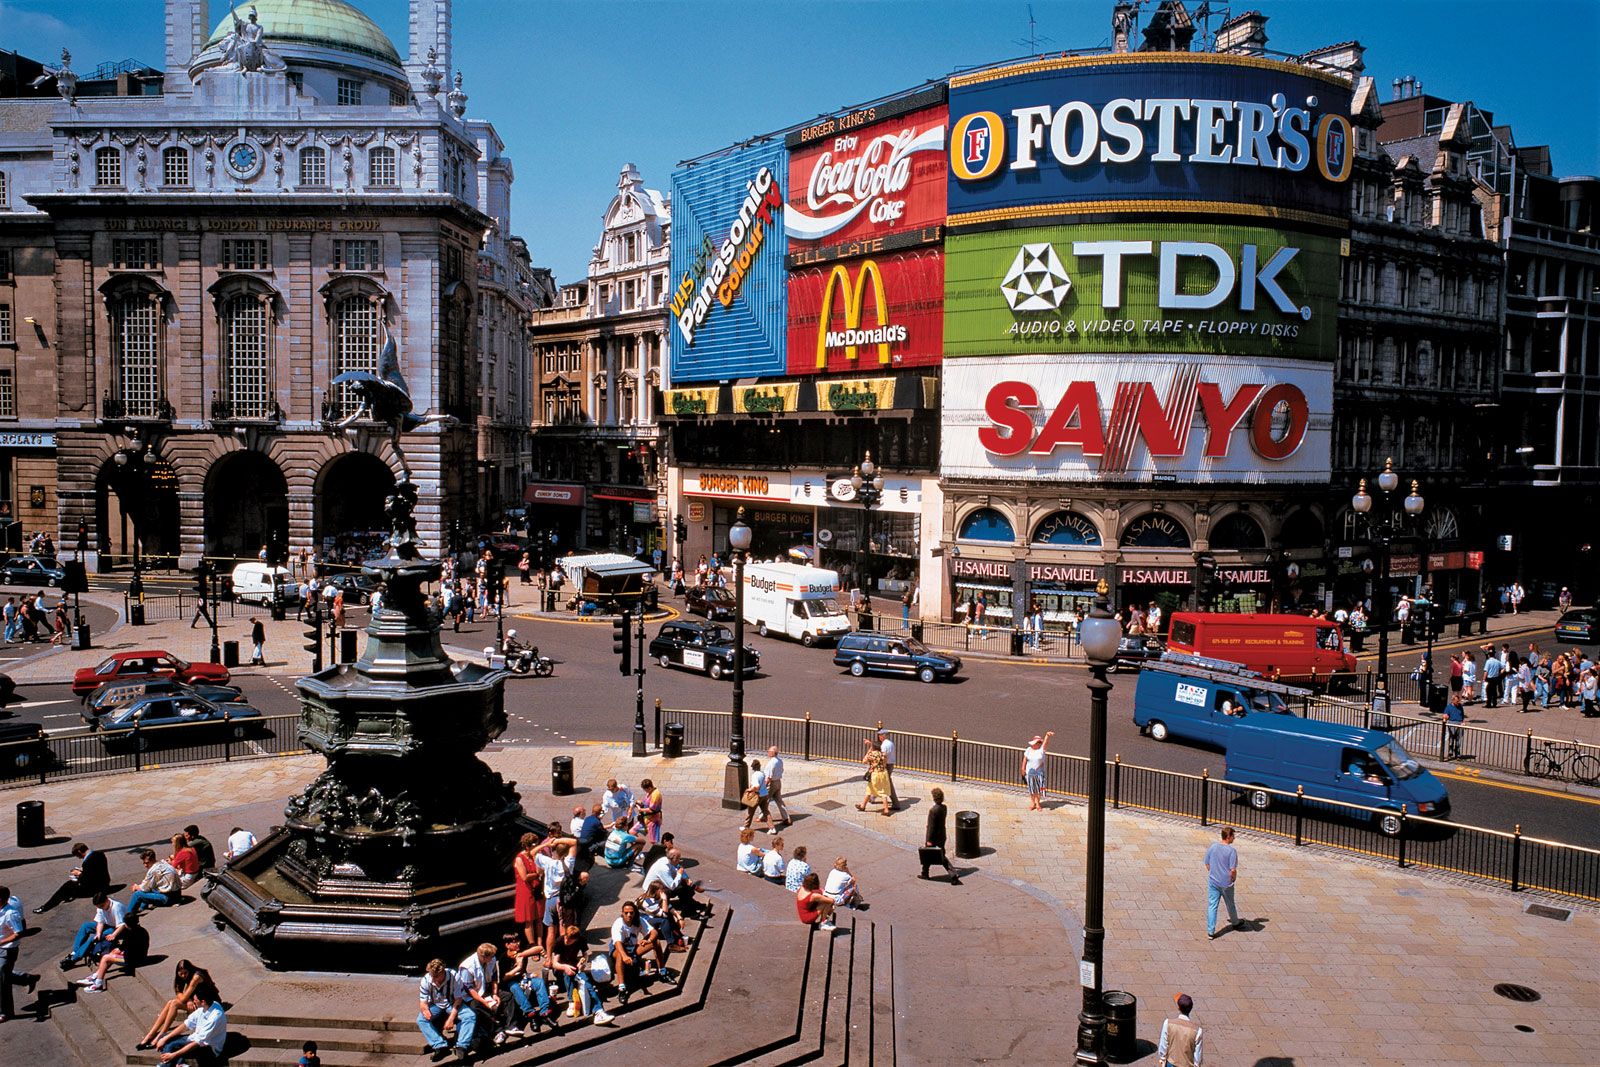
[944,219,1341,360]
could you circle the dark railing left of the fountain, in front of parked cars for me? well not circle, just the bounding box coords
[0,715,306,789]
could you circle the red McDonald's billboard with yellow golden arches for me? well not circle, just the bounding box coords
[789,246,944,374]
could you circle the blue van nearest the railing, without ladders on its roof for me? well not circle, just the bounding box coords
[1226,715,1450,835]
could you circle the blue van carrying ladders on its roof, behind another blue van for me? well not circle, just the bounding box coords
[1133,653,1310,745]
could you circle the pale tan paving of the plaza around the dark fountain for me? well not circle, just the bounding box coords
[0,745,1600,1067]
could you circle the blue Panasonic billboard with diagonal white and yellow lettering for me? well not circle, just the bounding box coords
[667,141,789,382]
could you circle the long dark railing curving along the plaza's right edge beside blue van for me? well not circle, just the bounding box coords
[656,704,1600,902]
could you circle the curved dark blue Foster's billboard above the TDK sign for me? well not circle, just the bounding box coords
[949,53,1354,226]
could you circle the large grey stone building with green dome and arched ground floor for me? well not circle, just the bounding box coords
[0,0,530,569]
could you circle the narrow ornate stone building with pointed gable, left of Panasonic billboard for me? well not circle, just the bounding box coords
[525,163,672,552]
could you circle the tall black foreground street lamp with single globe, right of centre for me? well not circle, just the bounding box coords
[1075,579,1122,1064]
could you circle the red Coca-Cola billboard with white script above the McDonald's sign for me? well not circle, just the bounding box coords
[784,88,947,254]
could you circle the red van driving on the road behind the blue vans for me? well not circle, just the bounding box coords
[1166,611,1355,685]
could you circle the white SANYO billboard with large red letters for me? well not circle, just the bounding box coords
[939,352,1333,485]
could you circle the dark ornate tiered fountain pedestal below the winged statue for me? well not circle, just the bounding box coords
[205,480,541,969]
